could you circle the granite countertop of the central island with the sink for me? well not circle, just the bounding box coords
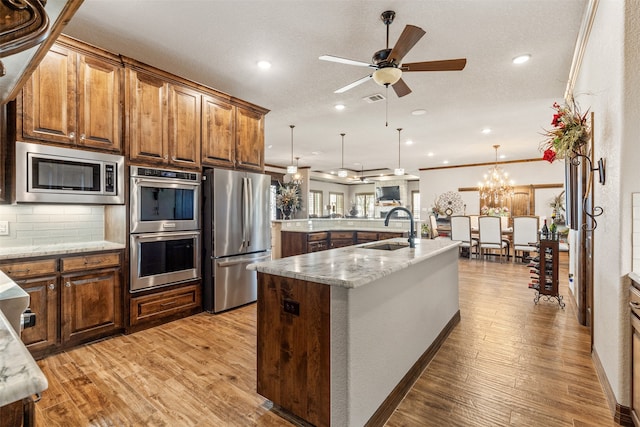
[247,238,460,288]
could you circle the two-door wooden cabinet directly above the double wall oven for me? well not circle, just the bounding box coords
[126,68,202,168]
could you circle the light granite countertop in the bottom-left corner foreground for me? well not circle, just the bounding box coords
[0,300,48,406]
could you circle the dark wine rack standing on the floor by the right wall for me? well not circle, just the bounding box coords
[529,233,565,308]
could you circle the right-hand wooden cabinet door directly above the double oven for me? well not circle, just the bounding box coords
[169,85,202,168]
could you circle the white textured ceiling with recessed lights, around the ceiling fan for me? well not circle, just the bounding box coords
[64,0,586,181]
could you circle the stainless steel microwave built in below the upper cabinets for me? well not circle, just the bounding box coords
[16,141,125,204]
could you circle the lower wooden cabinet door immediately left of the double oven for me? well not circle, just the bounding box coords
[61,269,123,343]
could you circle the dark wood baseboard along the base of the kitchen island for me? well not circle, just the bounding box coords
[365,310,460,427]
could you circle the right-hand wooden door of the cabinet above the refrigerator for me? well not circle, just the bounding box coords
[236,107,264,171]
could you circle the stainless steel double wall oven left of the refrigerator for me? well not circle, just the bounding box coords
[130,166,201,292]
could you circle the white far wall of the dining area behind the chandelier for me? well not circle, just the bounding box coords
[420,160,564,218]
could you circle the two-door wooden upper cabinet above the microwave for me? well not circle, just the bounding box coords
[17,37,123,152]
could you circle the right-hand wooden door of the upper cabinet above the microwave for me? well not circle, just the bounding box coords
[77,55,123,152]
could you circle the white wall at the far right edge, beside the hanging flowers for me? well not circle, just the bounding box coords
[574,0,640,406]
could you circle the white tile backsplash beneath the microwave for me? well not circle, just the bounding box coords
[0,204,104,248]
